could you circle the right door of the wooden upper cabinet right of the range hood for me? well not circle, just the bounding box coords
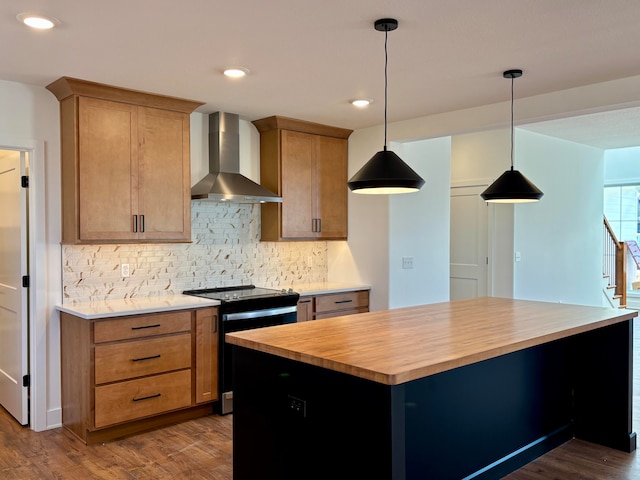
[313,136,348,240]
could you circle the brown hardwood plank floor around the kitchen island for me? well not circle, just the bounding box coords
[0,319,640,480]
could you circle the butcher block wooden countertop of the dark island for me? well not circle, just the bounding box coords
[226,297,638,385]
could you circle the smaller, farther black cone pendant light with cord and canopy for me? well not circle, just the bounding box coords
[480,70,543,203]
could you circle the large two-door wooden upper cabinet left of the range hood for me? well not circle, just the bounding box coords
[47,77,202,243]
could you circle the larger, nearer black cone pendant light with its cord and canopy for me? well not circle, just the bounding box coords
[347,18,424,194]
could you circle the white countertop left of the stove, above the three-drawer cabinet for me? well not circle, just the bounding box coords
[56,294,220,320]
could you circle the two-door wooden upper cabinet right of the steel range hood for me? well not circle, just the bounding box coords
[253,117,352,241]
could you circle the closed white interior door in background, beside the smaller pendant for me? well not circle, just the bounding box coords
[449,185,489,300]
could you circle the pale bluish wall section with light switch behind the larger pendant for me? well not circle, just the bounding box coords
[388,137,451,308]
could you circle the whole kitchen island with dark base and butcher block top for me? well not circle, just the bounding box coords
[227,298,637,480]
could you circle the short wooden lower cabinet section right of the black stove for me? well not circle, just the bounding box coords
[298,290,369,322]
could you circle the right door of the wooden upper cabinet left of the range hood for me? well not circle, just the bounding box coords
[138,107,191,241]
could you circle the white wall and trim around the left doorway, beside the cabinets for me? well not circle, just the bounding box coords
[0,81,62,430]
